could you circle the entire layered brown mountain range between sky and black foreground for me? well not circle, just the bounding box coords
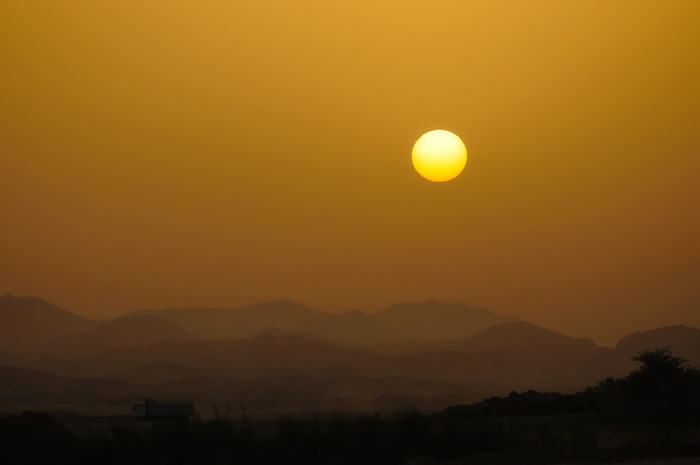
[0,295,700,411]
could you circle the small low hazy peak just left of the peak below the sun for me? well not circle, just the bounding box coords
[294,310,410,346]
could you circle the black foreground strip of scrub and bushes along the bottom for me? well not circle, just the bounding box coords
[0,347,700,465]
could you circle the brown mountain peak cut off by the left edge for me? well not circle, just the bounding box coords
[0,294,96,351]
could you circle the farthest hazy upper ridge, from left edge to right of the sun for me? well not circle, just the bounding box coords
[0,295,524,352]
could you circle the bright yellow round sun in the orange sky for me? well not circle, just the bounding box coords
[411,129,467,182]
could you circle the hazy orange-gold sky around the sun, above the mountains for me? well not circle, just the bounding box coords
[0,0,700,343]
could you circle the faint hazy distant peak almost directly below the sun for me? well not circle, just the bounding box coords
[374,300,517,341]
